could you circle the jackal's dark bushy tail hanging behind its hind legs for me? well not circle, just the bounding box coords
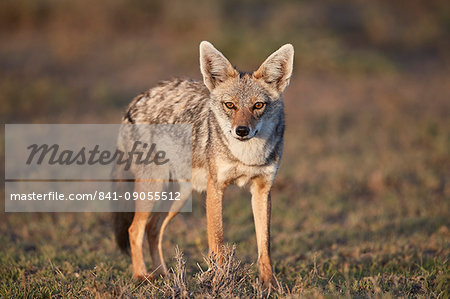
[112,166,134,253]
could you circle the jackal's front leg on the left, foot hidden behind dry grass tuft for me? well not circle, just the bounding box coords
[206,178,223,261]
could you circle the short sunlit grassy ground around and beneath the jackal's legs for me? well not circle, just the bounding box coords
[0,74,450,298]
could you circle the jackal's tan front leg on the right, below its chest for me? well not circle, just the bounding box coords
[251,177,274,287]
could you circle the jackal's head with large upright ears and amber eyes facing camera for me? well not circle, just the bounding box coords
[200,41,294,141]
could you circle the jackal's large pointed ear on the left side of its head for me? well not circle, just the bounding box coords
[200,41,239,91]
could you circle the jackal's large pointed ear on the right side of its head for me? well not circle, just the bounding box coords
[253,44,294,94]
